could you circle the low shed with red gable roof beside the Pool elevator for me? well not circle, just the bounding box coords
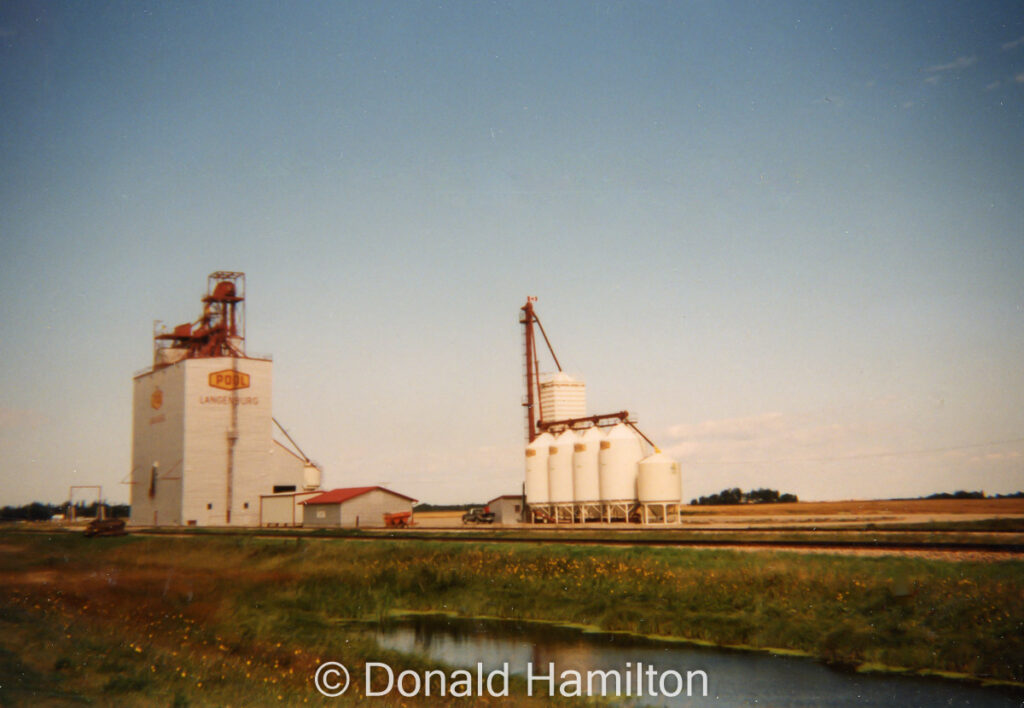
[302,487,417,529]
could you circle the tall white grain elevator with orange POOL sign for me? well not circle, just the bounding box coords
[131,270,319,526]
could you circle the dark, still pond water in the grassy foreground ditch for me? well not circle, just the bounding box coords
[373,615,1024,708]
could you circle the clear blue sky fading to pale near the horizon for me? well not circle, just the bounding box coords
[0,2,1024,503]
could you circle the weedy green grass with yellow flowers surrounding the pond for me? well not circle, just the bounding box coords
[0,533,1024,705]
